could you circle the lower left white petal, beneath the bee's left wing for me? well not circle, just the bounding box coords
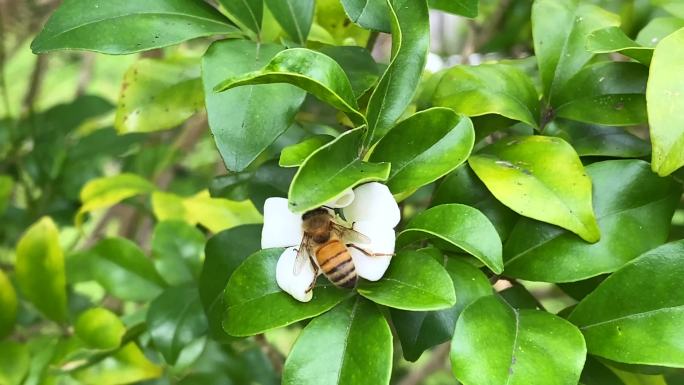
[276,247,315,302]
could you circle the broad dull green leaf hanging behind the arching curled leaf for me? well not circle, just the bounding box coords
[202,40,306,171]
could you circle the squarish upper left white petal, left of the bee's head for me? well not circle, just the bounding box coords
[261,198,304,249]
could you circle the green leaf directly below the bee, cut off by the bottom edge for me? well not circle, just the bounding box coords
[283,297,392,385]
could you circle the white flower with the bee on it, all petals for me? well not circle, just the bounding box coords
[261,182,400,302]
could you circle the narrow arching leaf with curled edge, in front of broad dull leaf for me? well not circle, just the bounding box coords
[214,46,366,126]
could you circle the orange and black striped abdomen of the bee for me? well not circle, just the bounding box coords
[316,239,357,289]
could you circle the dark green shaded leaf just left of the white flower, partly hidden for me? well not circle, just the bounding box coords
[199,225,261,339]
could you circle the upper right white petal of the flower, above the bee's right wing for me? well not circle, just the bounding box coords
[342,182,401,228]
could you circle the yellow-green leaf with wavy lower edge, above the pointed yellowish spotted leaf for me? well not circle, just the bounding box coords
[431,64,539,127]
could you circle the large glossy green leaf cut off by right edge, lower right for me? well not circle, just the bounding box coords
[569,241,684,368]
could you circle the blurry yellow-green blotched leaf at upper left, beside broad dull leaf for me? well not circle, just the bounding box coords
[114,59,204,134]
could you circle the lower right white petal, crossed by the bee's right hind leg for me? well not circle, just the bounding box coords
[349,221,395,281]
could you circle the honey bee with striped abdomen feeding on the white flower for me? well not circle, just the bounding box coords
[294,207,391,292]
